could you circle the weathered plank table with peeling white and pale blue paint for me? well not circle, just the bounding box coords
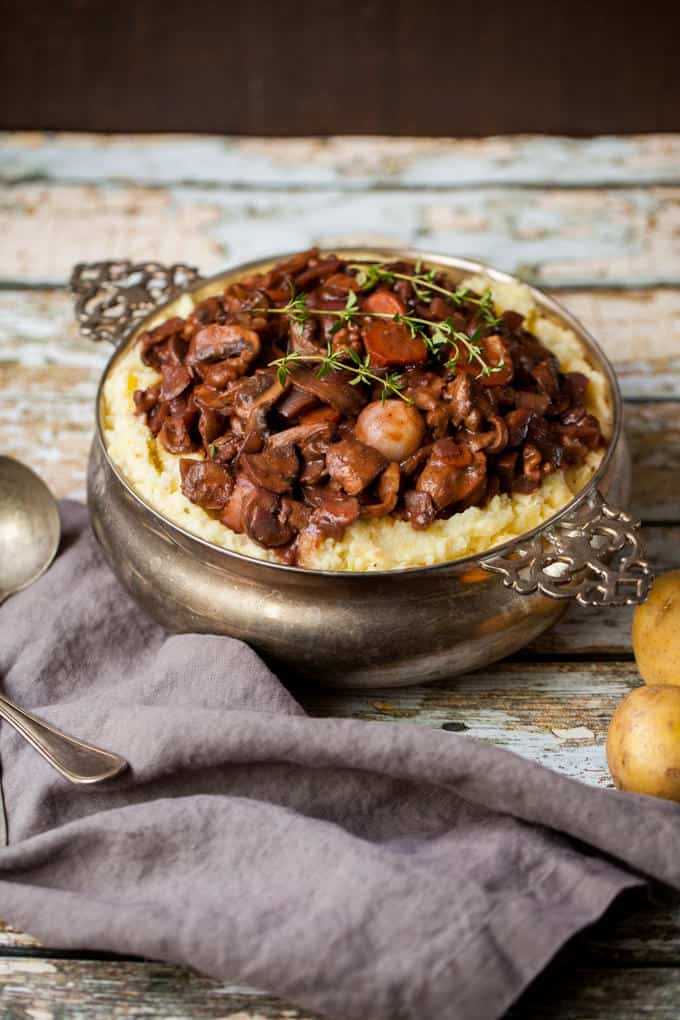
[0,135,680,1020]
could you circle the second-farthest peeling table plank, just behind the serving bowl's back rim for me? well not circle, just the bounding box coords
[0,183,680,288]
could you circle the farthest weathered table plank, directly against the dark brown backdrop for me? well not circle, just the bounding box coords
[0,132,680,190]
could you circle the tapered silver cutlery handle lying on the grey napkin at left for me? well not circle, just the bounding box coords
[0,695,127,783]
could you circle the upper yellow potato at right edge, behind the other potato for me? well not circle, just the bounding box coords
[633,570,680,683]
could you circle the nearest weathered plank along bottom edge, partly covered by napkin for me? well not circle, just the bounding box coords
[0,958,680,1020]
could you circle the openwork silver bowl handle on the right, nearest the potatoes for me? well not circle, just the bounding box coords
[481,490,653,606]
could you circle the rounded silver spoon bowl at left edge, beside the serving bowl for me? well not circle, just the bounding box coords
[0,457,61,602]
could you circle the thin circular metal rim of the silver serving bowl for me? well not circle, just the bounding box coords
[95,245,623,580]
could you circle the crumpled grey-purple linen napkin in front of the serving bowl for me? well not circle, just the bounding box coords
[0,504,680,1020]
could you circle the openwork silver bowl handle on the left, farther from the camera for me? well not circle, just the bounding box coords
[70,259,201,345]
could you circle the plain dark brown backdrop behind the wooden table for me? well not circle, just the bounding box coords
[0,0,680,136]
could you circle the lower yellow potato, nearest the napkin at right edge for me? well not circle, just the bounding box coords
[607,684,680,802]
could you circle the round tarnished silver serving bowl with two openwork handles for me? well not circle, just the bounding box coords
[71,250,651,687]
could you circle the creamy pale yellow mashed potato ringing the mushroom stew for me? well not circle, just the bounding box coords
[103,277,613,570]
